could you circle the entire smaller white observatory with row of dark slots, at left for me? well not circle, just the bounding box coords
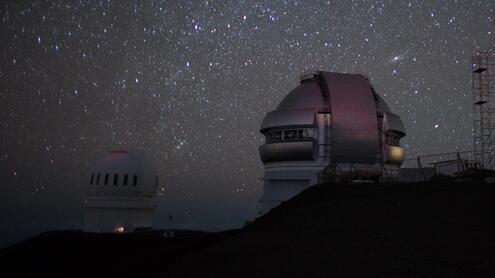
[84,150,158,232]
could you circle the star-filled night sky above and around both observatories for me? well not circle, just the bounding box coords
[0,0,495,248]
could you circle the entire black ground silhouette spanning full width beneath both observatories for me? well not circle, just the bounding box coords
[0,181,495,278]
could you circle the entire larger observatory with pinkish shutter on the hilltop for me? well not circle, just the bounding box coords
[259,71,406,214]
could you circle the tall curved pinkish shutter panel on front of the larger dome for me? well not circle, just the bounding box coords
[320,72,378,164]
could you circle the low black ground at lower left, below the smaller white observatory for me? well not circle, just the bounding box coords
[0,230,237,278]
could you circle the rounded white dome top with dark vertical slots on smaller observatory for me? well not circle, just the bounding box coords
[87,150,158,197]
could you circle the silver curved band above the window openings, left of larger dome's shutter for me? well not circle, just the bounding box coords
[261,109,315,132]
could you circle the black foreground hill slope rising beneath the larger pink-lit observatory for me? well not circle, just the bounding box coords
[166,182,495,277]
